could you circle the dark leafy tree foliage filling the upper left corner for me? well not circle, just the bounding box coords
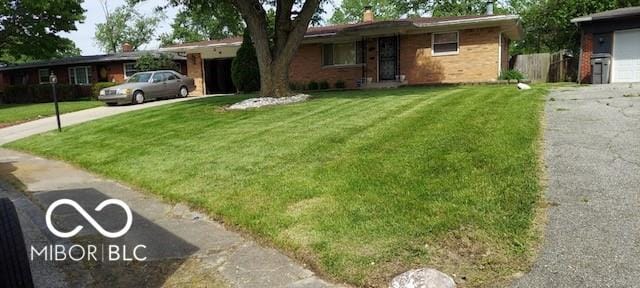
[0,0,84,62]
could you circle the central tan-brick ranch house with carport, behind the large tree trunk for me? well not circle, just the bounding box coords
[160,5,522,94]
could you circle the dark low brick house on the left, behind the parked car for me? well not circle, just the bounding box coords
[0,45,187,92]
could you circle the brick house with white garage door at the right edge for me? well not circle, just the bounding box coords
[571,7,640,84]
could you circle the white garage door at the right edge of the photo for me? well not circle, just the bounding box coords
[611,30,640,83]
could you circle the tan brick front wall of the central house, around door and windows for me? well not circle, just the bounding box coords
[289,27,502,88]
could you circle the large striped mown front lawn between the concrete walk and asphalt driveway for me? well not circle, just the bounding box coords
[9,86,547,287]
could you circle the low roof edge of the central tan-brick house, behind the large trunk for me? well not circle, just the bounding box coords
[160,15,520,51]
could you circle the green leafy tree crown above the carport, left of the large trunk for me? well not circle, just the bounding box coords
[160,2,244,45]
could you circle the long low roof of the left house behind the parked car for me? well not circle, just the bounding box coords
[0,51,187,71]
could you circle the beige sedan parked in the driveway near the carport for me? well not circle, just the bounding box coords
[98,70,196,105]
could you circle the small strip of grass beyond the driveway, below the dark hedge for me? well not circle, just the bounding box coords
[0,101,103,127]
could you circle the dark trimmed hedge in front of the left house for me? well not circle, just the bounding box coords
[0,84,91,104]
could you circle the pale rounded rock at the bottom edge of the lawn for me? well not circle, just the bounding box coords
[389,268,456,288]
